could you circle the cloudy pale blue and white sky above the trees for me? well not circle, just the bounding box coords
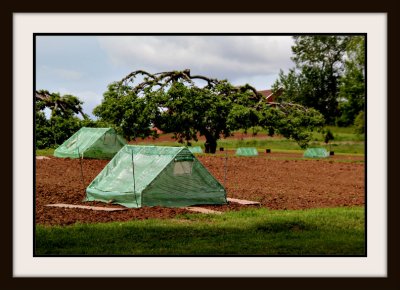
[36,36,294,117]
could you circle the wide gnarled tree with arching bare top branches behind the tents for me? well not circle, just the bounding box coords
[93,70,324,153]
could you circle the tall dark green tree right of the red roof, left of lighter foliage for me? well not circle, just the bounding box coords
[273,35,347,123]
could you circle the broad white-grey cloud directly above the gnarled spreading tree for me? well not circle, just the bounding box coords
[98,36,293,81]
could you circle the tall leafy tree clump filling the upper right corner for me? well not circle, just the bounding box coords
[273,35,365,126]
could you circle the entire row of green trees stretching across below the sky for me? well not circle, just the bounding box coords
[35,35,365,152]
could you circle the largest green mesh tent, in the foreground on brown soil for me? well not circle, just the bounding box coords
[86,145,227,208]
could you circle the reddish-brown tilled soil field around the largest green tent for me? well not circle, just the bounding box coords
[35,152,365,225]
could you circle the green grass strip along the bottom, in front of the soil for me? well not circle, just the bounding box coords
[36,207,365,256]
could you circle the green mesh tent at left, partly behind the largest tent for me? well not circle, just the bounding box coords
[54,127,126,159]
